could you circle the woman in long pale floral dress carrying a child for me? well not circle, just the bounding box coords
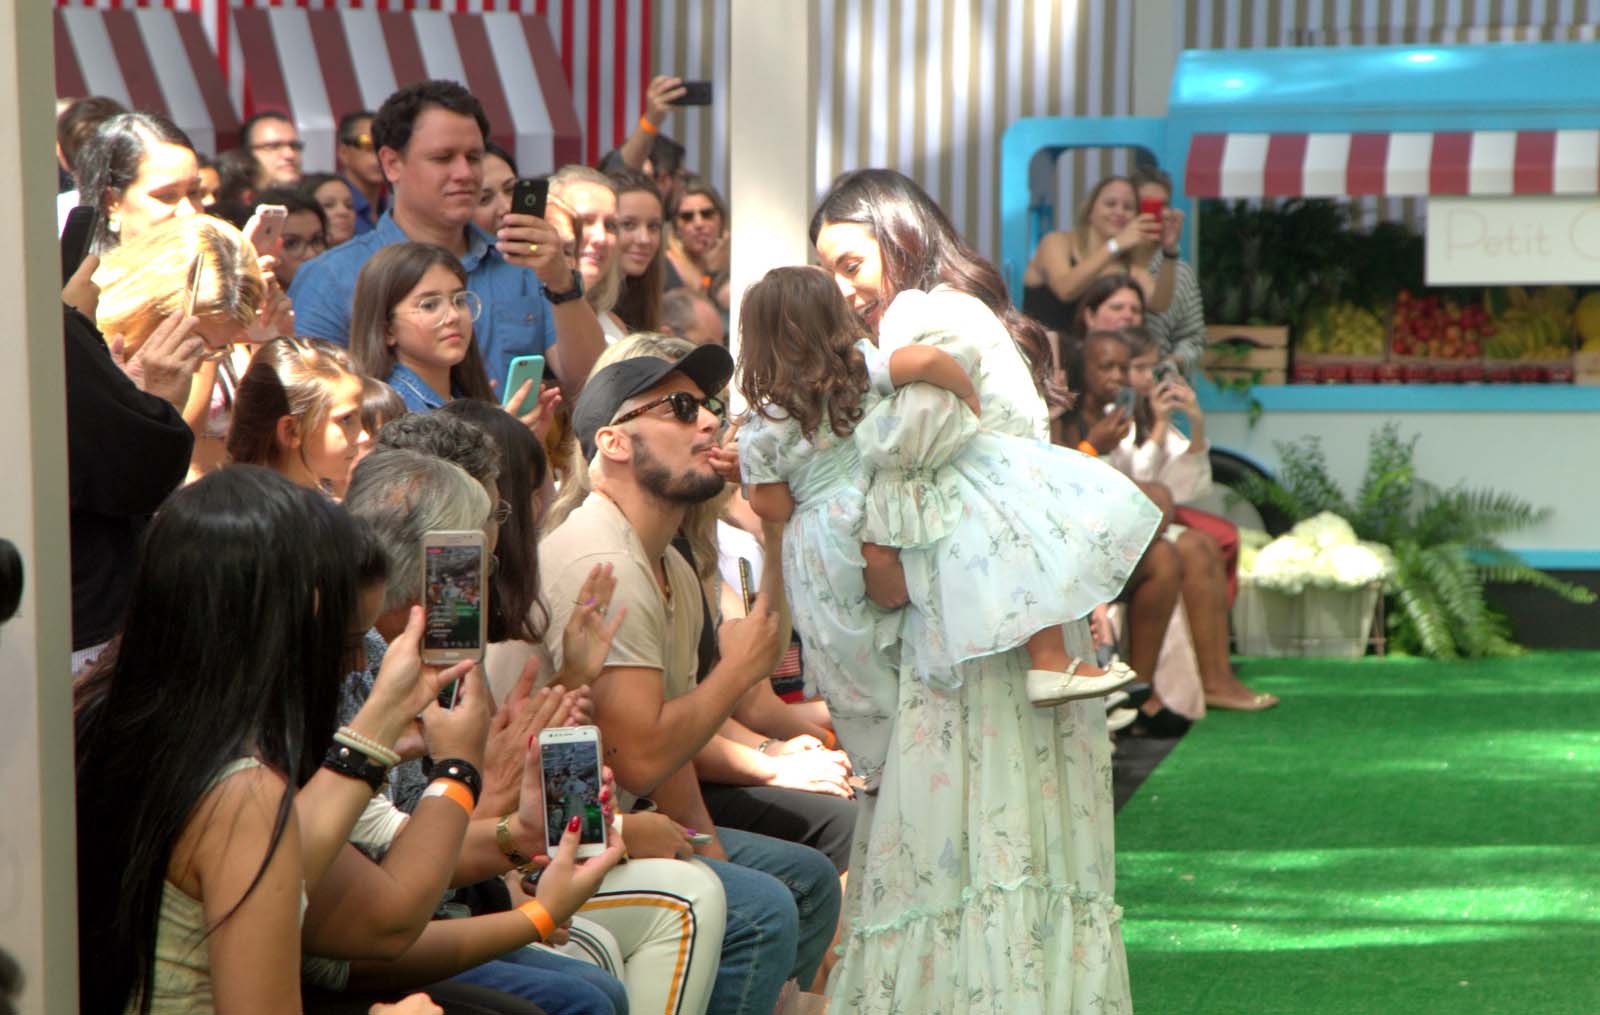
[811,170,1131,1015]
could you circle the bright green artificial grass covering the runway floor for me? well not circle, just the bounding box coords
[1117,653,1600,1015]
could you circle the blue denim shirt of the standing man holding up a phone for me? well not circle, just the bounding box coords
[290,213,555,384]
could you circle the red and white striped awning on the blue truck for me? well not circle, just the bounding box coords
[1184,130,1600,197]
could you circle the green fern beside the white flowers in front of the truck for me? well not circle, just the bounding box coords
[1237,423,1595,660]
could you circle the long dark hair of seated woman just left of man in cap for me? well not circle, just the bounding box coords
[438,399,550,642]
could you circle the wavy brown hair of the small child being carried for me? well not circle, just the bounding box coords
[739,267,867,440]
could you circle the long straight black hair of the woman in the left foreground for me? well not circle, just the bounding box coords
[74,466,370,1012]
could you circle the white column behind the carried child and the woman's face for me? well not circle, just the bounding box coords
[726,0,816,408]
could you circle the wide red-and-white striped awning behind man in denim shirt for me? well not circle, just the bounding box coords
[232,6,582,175]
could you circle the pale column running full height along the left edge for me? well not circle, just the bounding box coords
[0,3,77,1012]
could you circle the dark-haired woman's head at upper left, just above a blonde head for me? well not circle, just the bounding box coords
[75,112,200,255]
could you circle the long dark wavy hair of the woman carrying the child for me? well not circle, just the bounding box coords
[811,170,1051,402]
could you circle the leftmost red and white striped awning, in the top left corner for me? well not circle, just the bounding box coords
[54,8,238,152]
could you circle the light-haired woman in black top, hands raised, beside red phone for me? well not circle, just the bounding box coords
[1022,176,1181,335]
